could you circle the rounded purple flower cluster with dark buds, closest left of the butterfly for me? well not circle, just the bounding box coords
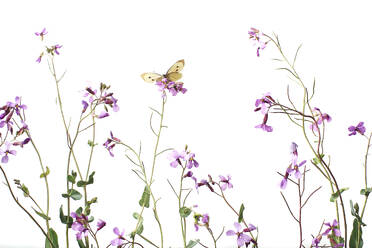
[81,83,119,119]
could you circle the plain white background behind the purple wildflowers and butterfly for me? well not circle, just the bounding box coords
[0,0,372,248]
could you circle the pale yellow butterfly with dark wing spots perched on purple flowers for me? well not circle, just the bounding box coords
[141,59,185,83]
